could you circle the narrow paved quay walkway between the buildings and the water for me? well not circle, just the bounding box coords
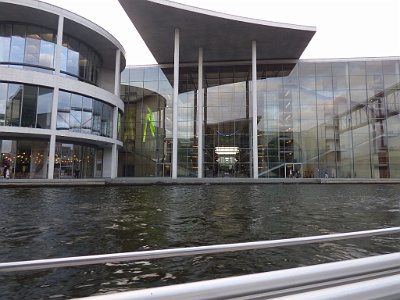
[0,177,400,188]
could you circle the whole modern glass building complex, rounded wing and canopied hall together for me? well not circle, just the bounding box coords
[0,0,400,179]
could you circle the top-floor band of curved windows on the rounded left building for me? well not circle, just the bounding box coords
[0,23,102,85]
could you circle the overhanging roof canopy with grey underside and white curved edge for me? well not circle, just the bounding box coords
[119,0,316,64]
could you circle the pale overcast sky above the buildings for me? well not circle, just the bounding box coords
[44,0,400,65]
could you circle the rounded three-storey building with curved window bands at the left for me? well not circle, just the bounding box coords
[0,0,125,179]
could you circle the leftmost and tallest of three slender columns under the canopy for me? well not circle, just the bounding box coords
[172,28,179,179]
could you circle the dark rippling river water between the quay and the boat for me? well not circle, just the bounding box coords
[0,184,400,300]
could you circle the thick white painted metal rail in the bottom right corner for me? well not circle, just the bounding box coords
[73,253,400,300]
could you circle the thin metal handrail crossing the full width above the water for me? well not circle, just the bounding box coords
[0,227,400,274]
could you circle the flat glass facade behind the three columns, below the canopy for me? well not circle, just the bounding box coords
[118,58,400,178]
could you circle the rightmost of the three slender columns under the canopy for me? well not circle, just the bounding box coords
[252,41,258,178]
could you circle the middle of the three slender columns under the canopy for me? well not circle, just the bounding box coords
[197,48,204,178]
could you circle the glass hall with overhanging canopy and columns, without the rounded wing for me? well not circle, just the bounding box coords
[118,0,400,178]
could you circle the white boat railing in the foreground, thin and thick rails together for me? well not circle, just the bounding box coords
[0,227,400,300]
